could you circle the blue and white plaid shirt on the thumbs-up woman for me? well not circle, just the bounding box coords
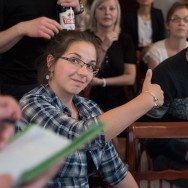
[20,85,128,188]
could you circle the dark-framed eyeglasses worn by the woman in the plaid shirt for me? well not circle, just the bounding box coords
[60,57,99,75]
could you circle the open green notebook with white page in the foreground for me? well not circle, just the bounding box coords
[0,122,104,185]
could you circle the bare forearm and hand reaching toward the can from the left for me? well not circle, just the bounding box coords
[0,17,62,53]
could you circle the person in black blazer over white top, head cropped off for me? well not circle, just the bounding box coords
[123,0,165,90]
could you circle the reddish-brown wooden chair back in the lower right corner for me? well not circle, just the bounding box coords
[127,122,188,187]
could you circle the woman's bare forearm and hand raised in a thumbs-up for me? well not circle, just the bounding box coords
[99,70,164,140]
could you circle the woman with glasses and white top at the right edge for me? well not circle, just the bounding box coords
[144,2,188,69]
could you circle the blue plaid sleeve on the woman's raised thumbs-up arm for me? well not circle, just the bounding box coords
[20,94,104,140]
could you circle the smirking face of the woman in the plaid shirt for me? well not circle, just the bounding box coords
[48,41,97,95]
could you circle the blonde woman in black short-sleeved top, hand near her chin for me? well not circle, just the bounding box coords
[86,0,136,154]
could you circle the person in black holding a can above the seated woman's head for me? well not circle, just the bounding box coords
[0,0,83,100]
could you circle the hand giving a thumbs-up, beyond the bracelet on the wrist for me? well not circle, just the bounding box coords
[142,69,164,106]
